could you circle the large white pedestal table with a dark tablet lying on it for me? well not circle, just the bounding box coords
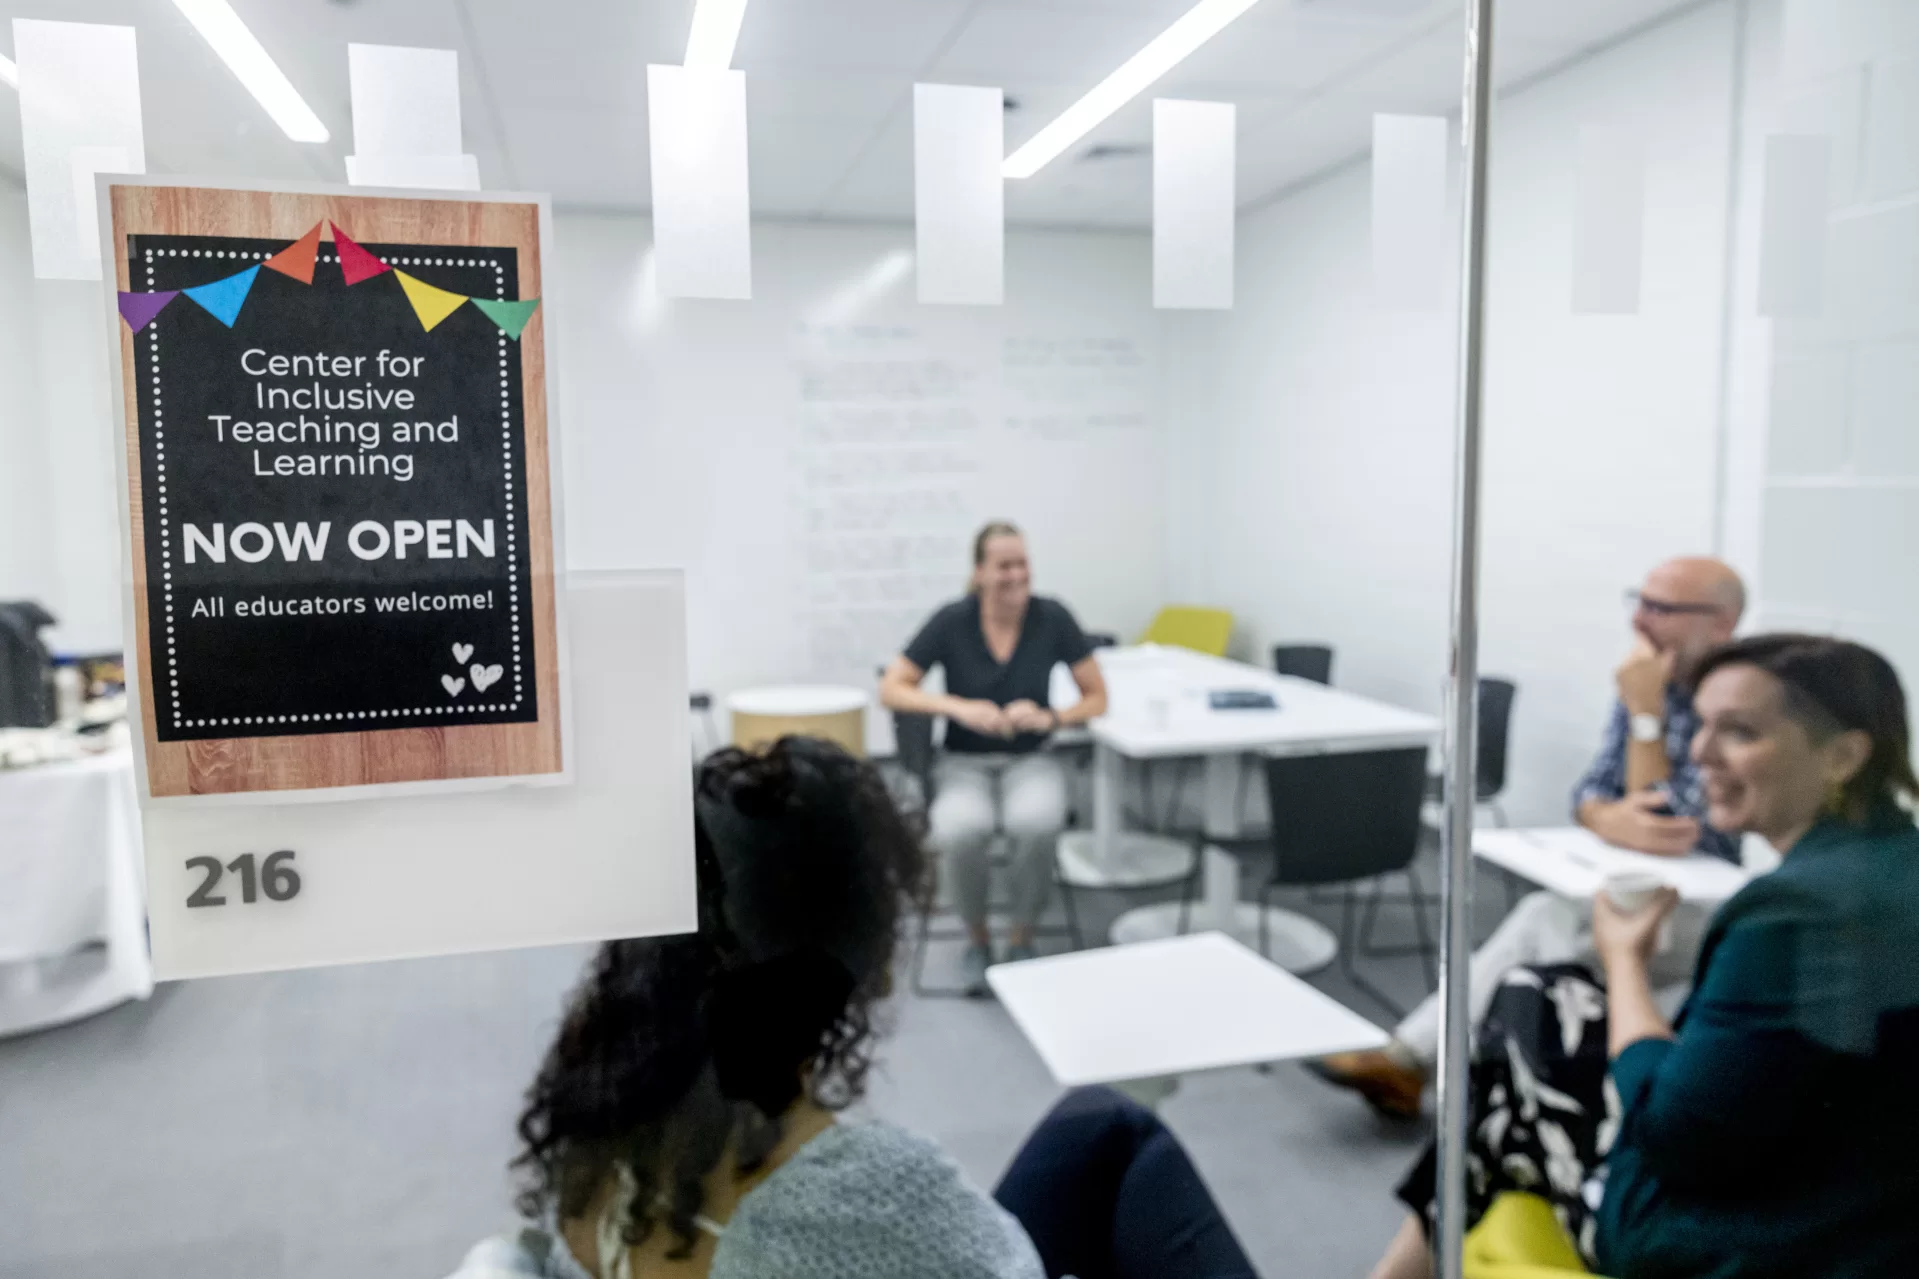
[1059,645,1439,972]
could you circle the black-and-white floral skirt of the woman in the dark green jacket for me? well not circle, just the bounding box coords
[1399,964,1620,1264]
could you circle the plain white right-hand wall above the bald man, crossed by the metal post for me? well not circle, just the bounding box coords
[1174,0,1735,822]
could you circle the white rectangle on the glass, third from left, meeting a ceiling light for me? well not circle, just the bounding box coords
[647,65,752,298]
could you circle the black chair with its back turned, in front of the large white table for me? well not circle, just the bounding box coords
[1259,747,1437,1016]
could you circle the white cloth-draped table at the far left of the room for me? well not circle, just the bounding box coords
[0,749,154,1035]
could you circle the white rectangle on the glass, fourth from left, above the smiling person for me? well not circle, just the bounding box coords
[913,84,1006,305]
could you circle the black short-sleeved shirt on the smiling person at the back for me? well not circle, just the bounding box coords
[906,595,1092,755]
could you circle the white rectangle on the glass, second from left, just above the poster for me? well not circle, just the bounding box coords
[347,44,480,190]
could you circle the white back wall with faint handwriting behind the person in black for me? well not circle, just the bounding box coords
[557,215,1171,693]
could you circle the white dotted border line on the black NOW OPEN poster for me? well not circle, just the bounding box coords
[146,250,526,728]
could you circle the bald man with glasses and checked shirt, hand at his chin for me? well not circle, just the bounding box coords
[1307,557,1746,1118]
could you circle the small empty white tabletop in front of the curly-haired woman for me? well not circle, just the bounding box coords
[986,933,1387,1095]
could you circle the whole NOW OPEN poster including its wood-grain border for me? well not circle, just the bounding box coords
[115,188,558,795]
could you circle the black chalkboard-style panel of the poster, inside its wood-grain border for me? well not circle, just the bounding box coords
[129,236,539,741]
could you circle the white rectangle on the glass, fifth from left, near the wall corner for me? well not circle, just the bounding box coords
[1153,98,1236,311]
